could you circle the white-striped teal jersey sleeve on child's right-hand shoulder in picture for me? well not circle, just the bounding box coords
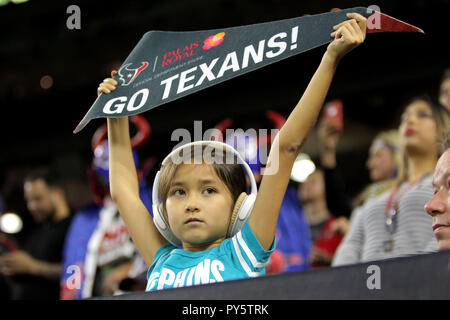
[232,221,276,277]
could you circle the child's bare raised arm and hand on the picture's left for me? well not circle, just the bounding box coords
[99,73,167,265]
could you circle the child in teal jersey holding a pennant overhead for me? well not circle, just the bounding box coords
[98,13,366,291]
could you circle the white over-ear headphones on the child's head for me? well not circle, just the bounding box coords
[152,141,257,246]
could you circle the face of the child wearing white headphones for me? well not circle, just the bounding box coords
[166,164,233,251]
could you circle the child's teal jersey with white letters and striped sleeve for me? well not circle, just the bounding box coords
[145,221,275,291]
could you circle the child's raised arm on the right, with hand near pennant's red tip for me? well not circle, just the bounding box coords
[249,13,366,250]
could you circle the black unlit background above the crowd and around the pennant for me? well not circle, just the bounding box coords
[0,0,450,235]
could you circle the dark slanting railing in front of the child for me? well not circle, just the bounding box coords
[93,250,450,300]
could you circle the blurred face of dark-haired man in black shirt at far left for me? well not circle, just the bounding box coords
[24,179,55,222]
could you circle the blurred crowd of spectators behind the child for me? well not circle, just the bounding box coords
[0,60,450,300]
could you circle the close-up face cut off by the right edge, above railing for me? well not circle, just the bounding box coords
[425,149,450,250]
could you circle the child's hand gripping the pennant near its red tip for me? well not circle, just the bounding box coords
[327,13,367,60]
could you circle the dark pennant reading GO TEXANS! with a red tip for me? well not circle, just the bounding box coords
[74,7,423,133]
